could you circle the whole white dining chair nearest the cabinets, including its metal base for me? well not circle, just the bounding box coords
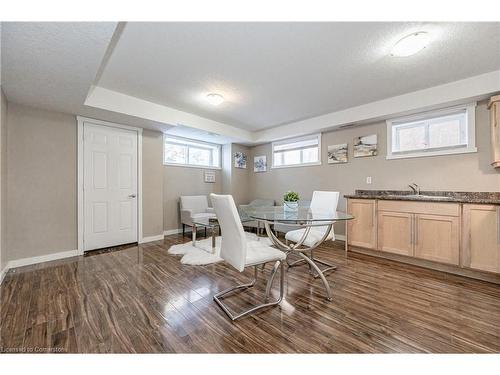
[285,191,340,277]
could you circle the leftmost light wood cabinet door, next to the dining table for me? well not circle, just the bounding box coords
[347,199,377,249]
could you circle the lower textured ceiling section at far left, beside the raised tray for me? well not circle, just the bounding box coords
[2,22,116,113]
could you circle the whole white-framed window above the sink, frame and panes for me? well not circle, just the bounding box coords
[387,103,477,159]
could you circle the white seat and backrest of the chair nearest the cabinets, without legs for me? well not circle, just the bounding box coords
[285,191,339,247]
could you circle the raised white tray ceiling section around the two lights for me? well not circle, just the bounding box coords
[98,22,500,130]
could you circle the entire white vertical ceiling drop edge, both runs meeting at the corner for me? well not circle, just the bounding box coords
[85,70,500,145]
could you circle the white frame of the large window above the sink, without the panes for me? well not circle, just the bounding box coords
[386,102,477,160]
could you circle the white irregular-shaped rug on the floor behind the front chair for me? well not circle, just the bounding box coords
[168,233,271,266]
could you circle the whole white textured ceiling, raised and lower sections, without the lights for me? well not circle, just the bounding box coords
[1,22,500,142]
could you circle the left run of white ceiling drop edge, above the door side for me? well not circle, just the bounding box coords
[85,86,253,143]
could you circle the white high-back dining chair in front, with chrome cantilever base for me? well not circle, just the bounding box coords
[210,194,286,320]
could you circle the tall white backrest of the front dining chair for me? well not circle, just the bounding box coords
[210,194,247,272]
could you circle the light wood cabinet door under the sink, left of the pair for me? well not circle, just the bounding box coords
[377,211,413,256]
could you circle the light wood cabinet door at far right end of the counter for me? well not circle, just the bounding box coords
[462,204,500,273]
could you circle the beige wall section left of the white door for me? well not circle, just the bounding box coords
[7,103,77,260]
